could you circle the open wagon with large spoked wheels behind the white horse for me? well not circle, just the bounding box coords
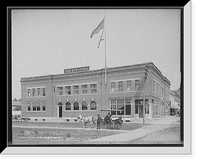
[100,117,123,130]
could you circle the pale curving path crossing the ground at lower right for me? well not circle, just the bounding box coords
[88,116,180,144]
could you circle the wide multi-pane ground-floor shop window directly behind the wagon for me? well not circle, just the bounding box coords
[111,99,131,115]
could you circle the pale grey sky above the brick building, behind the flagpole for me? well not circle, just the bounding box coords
[11,9,181,99]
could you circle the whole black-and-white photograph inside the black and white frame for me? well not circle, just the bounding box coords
[1,3,190,155]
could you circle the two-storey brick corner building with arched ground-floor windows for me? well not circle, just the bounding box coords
[21,62,170,121]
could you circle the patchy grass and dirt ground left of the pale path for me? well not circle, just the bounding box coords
[12,122,144,144]
